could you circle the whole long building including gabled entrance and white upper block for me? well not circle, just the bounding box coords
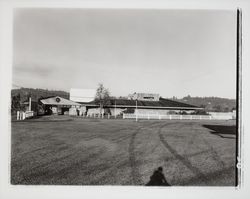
[35,90,203,116]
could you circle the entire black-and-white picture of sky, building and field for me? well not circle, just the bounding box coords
[3,0,250,197]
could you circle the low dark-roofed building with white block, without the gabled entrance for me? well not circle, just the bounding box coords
[70,89,203,116]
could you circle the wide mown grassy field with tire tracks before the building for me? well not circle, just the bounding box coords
[11,116,236,186]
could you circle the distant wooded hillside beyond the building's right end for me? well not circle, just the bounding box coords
[171,96,236,112]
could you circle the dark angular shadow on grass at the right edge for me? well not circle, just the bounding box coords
[203,124,237,139]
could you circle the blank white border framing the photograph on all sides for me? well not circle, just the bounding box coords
[0,0,250,199]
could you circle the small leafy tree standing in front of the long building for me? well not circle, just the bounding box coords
[95,83,110,115]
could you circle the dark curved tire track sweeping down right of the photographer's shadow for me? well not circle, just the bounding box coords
[158,124,209,183]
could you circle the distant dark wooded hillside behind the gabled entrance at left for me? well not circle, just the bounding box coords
[11,88,69,102]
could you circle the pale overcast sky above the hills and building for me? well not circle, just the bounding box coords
[13,9,236,98]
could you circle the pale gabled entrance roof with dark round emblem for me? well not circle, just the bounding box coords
[40,96,80,106]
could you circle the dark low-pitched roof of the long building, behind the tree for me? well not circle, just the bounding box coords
[89,98,202,110]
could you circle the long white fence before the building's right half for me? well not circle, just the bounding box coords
[123,113,233,120]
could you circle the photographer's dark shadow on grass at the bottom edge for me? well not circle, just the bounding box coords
[146,167,171,186]
